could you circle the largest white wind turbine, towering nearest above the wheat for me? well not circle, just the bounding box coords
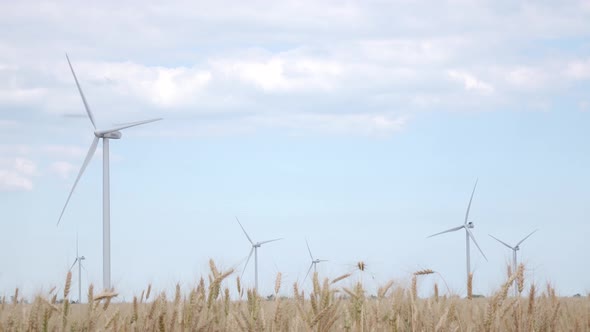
[57,54,161,290]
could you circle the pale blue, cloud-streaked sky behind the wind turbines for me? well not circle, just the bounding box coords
[0,0,590,300]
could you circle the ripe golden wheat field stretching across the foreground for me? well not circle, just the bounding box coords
[0,261,590,331]
